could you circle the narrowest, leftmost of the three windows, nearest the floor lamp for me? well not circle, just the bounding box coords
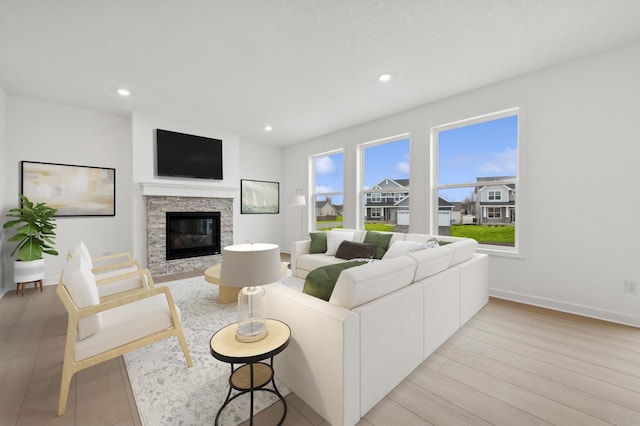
[309,151,344,230]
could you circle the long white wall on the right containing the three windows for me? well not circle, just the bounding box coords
[285,42,640,326]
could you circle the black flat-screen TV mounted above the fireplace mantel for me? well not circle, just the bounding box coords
[156,129,222,179]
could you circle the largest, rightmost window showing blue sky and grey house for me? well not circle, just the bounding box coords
[432,109,519,251]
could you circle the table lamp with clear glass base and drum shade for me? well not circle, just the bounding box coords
[220,243,282,342]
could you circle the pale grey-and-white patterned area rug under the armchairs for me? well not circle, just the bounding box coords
[124,276,303,426]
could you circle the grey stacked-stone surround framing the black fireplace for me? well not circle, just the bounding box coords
[146,196,233,276]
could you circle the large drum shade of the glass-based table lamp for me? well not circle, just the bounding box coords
[220,243,282,287]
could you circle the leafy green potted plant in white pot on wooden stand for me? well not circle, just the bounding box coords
[3,194,58,283]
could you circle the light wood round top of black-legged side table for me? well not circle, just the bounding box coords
[210,319,291,363]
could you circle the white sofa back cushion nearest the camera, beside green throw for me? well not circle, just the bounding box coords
[329,256,416,309]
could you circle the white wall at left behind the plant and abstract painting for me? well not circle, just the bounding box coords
[0,95,132,290]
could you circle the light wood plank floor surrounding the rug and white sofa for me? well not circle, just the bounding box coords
[0,280,640,426]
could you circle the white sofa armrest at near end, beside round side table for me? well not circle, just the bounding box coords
[263,283,360,426]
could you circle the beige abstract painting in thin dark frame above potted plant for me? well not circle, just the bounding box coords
[21,161,116,216]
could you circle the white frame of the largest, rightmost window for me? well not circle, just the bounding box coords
[429,107,526,258]
